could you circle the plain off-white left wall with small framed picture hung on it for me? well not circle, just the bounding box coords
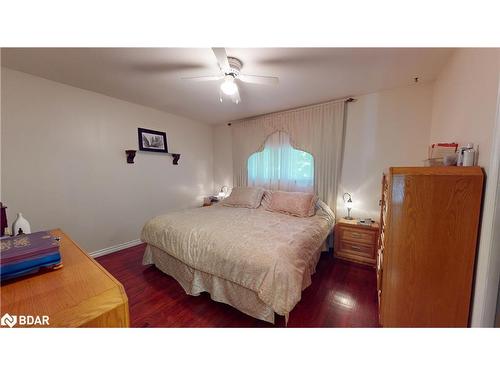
[1,69,213,252]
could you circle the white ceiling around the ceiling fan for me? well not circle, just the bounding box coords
[2,48,452,124]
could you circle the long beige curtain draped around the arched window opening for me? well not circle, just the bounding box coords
[231,101,345,211]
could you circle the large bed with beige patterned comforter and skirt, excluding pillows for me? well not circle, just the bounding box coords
[141,201,335,323]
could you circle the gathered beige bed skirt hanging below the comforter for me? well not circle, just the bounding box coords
[142,242,328,324]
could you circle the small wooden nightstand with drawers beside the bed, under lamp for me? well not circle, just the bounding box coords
[334,219,379,266]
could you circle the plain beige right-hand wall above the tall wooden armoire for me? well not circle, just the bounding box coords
[431,48,498,171]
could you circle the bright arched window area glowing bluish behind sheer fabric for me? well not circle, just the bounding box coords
[248,132,314,192]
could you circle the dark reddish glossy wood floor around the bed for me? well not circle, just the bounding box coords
[97,245,378,327]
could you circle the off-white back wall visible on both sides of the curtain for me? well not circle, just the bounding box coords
[214,83,432,219]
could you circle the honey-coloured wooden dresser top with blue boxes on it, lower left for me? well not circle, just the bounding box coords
[0,229,129,327]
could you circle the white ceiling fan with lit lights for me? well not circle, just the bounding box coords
[182,48,279,104]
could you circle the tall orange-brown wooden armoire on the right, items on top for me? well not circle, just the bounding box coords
[377,167,483,327]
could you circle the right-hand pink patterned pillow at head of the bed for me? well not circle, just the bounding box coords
[269,191,318,217]
